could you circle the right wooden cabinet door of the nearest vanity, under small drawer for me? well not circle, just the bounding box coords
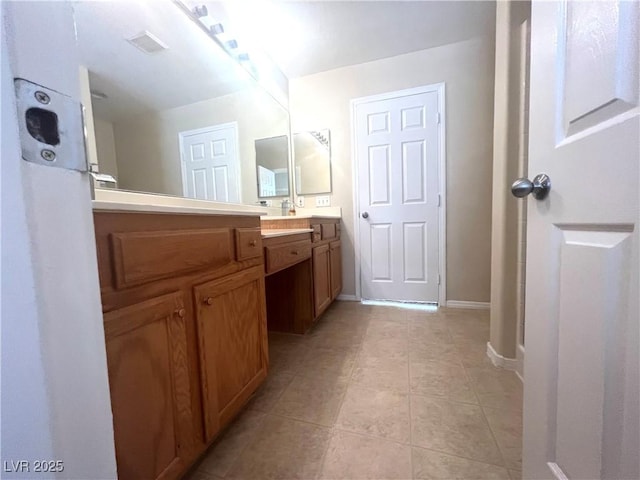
[194,266,268,441]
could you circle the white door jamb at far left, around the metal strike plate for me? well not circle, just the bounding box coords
[0,2,117,479]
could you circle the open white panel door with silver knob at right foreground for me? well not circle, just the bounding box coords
[520,1,640,479]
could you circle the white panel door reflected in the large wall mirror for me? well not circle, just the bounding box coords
[179,123,241,203]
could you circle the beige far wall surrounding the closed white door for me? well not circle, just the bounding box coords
[289,36,494,302]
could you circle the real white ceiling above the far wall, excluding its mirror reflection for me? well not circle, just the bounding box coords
[212,0,495,78]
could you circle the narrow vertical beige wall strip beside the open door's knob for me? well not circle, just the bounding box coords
[490,2,530,358]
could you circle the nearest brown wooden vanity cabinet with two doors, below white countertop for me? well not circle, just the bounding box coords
[94,211,268,480]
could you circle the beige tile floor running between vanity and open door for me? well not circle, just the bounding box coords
[187,302,522,480]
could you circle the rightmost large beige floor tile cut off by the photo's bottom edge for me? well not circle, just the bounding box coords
[412,447,509,480]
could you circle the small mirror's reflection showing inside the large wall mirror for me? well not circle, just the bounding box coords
[255,135,289,198]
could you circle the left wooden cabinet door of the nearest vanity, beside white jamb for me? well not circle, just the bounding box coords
[104,292,194,480]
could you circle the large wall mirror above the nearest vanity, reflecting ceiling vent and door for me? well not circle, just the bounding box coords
[74,0,290,204]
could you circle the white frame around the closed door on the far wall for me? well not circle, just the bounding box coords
[350,82,447,307]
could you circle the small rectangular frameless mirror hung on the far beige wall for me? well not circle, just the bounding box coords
[293,130,331,195]
